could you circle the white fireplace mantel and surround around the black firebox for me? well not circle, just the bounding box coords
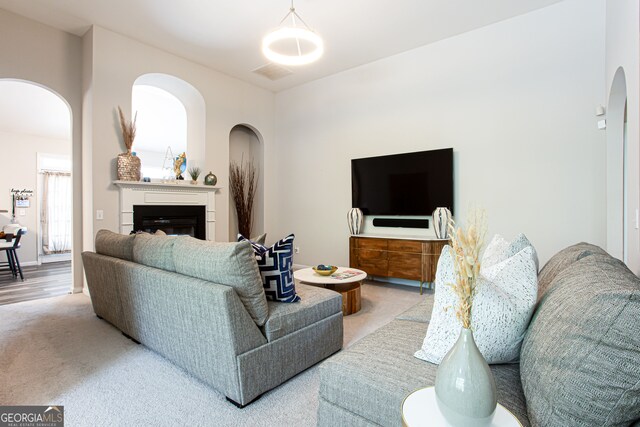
[113,181,220,240]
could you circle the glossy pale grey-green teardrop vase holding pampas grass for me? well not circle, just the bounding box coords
[435,327,498,427]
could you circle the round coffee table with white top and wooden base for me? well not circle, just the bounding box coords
[293,267,367,316]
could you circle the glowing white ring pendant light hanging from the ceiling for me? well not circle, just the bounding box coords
[262,0,324,65]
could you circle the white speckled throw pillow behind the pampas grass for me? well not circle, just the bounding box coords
[415,242,538,364]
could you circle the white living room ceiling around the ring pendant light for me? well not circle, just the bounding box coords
[0,0,561,91]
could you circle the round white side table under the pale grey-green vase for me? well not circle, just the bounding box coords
[402,387,522,427]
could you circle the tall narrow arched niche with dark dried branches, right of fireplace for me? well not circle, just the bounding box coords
[229,123,265,242]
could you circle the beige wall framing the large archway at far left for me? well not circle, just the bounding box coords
[0,9,83,291]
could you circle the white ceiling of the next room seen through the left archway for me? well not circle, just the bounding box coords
[0,80,71,140]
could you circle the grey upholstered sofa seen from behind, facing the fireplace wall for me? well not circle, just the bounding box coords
[82,230,343,406]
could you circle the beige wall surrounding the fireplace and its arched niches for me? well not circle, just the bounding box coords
[84,26,274,247]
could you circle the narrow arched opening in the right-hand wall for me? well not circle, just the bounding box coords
[607,67,631,262]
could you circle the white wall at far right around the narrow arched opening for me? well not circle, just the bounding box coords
[605,0,640,274]
